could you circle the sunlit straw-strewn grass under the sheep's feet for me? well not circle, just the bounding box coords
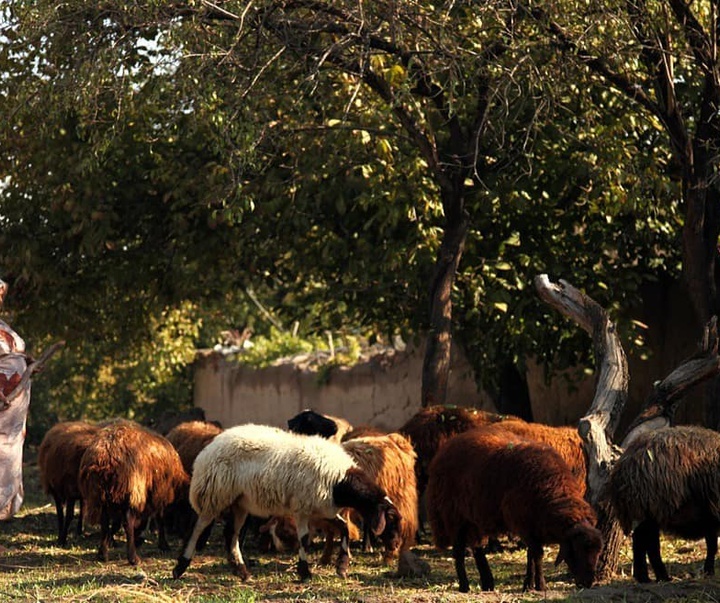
[0,462,720,603]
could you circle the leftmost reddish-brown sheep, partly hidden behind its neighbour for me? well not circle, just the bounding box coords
[38,421,100,547]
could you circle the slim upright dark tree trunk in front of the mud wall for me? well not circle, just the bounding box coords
[421,191,468,407]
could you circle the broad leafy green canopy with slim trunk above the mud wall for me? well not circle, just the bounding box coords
[0,0,691,432]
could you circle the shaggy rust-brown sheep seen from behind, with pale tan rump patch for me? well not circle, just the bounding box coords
[78,419,189,565]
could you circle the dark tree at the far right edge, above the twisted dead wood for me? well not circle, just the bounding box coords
[526,0,720,426]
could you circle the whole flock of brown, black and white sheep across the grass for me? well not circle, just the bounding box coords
[38,406,720,592]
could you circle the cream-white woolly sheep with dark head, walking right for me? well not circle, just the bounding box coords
[173,424,400,581]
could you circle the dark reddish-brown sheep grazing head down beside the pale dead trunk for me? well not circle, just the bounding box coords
[427,425,602,592]
